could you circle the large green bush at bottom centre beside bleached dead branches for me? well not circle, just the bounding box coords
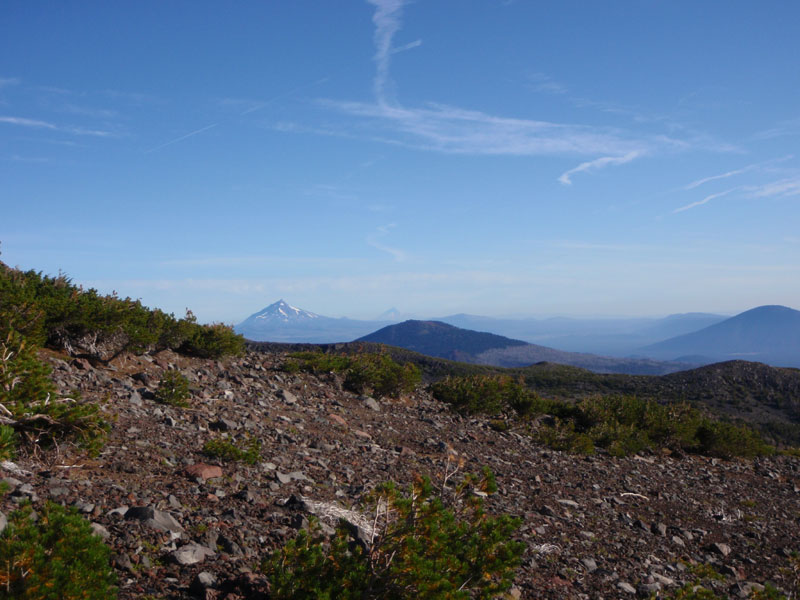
[263,470,524,600]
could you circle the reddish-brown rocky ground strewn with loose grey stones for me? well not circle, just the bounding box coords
[0,352,800,600]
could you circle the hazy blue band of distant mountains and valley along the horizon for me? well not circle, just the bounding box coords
[235,300,800,375]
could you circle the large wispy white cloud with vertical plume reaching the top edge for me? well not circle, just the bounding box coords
[312,0,693,171]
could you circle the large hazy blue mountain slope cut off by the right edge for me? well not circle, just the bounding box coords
[640,306,800,367]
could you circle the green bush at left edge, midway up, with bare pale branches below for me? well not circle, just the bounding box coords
[0,331,108,454]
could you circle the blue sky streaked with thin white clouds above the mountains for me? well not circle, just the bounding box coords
[0,0,800,322]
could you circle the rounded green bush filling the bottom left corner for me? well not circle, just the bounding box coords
[0,503,117,600]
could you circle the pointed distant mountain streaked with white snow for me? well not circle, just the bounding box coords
[234,300,387,344]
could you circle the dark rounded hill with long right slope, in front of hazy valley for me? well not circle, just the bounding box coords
[356,321,692,375]
